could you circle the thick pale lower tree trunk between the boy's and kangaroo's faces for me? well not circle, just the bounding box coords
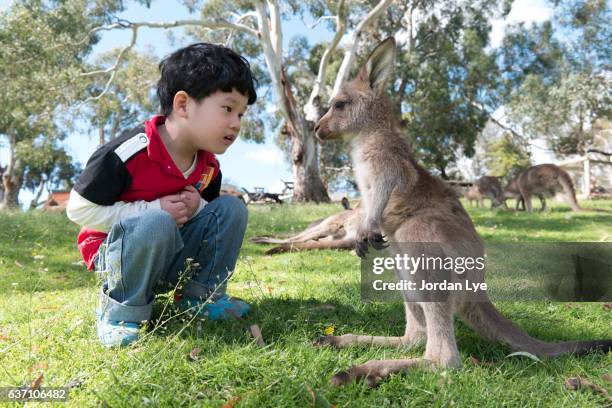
[281,68,330,203]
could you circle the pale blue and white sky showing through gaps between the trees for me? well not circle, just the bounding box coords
[0,0,552,205]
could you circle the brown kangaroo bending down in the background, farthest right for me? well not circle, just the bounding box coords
[517,164,582,212]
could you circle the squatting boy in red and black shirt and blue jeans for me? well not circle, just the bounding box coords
[67,43,257,346]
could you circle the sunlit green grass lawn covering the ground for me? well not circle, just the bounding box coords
[0,201,612,407]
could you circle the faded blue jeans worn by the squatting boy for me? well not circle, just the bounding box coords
[95,196,247,322]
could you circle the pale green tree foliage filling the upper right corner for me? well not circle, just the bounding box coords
[504,0,612,156]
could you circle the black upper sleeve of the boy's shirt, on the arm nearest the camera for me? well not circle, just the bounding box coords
[74,145,132,205]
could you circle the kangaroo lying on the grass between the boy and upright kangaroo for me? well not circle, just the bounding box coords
[249,199,362,255]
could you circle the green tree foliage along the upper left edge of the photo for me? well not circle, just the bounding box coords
[0,0,117,206]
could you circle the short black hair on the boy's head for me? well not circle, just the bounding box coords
[157,43,257,116]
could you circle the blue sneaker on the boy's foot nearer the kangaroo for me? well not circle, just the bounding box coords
[176,295,251,320]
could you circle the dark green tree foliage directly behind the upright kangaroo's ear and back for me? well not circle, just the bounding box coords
[400,2,499,177]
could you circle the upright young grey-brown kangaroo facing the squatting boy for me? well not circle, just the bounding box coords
[315,38,612,386]
